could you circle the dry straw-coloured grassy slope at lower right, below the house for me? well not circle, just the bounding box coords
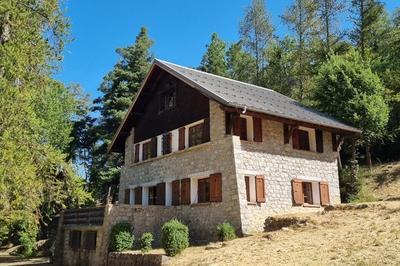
[168,202,400,266]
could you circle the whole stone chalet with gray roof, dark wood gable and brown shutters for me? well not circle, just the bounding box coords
[56,59,360,264]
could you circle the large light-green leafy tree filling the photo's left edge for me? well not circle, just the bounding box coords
[0,0,90,249]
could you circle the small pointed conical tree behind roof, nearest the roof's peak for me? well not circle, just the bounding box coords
[200,32,228,76]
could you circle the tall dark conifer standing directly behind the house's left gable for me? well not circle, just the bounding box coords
[88,28,153,200]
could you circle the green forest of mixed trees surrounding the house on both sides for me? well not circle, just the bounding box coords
[0,0,400,256]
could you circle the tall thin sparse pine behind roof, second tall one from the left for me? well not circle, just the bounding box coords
[282,0,319,101]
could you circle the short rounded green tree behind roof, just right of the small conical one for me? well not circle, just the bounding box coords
[226,41,256,83]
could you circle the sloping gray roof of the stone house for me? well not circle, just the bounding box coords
[155,59,361,133]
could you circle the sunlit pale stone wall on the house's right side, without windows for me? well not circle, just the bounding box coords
[233,120,340,233]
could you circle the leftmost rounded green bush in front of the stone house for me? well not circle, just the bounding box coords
[109,222,135,252]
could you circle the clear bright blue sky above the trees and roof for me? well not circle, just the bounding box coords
[56,0,400,99]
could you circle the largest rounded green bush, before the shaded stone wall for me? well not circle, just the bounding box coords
[161,219,189,257]
